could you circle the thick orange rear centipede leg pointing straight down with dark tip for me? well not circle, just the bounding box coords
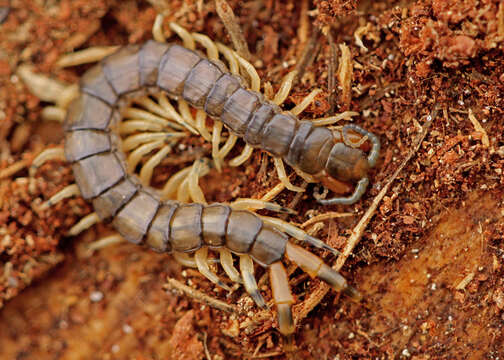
[269,262,296,348]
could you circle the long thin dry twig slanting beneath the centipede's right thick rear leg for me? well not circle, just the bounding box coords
[294,106,438,322]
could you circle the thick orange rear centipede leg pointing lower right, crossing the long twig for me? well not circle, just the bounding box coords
[285,243,362,301]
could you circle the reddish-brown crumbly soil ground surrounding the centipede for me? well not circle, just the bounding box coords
[0,0,504,359]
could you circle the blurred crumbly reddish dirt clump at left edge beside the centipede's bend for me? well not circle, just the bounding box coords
[0,154,89,308]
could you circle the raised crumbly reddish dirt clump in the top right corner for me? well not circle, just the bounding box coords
[400,0,504,76]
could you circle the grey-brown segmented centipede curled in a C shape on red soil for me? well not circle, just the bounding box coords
[27,15,380,350]
